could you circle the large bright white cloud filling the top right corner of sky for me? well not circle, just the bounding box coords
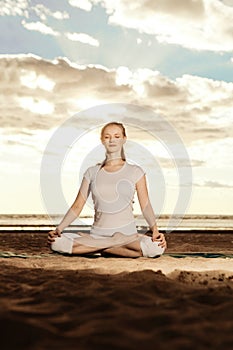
[92,0,233,52]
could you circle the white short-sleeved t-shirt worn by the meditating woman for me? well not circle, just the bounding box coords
[83,162,145,236]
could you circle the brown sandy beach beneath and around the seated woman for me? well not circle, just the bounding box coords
[0,232,233,349]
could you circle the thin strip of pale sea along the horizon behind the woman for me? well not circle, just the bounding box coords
[0,214,233,233]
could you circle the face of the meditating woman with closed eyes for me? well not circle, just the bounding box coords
[101,125,126,153]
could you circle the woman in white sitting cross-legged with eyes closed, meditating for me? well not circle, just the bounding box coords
[48,122,166,257]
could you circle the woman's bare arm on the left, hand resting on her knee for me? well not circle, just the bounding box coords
[48,178,89,244]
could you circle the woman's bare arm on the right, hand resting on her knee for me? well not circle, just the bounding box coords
[136,175,167,248]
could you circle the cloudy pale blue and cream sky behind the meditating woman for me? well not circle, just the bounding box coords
[0,0,233,215]
